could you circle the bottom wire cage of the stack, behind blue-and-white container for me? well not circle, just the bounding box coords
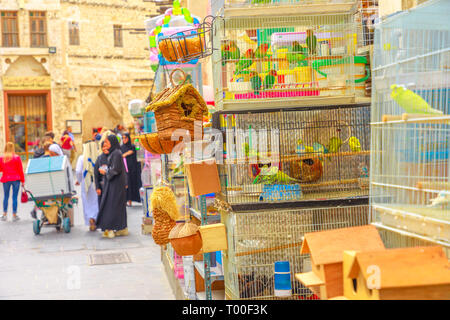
[221,205,369,299]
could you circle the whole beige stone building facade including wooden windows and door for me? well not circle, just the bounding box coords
[0,0,158,160]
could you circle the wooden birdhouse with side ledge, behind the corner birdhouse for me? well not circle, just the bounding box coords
[295,225,385,300]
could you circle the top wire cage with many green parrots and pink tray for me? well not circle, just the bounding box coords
[213,13,368,110]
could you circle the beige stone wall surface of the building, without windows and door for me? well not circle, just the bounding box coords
[0,0,156,158]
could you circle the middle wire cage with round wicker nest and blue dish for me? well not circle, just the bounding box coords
[217,105,370,204]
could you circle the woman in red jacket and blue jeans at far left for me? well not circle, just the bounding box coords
[0,142,25,221]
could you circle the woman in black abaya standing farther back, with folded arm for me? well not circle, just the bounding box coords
[120,133,142,207]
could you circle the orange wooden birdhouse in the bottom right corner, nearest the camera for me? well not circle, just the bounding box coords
[343,246,450,300]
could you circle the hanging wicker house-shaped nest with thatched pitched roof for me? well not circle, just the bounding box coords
[146,69,208,140]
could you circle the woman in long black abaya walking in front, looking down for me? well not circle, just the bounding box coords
[97,135,128,238]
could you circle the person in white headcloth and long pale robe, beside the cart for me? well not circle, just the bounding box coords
[75,141,99,231]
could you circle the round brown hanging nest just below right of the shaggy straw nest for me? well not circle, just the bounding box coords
[169,220,203,256]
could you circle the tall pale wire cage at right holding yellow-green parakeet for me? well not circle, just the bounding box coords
[370,1,450,248]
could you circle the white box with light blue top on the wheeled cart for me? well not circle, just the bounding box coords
[25,156,75,199]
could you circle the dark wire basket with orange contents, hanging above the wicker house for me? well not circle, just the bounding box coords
[158,16,215,63]
